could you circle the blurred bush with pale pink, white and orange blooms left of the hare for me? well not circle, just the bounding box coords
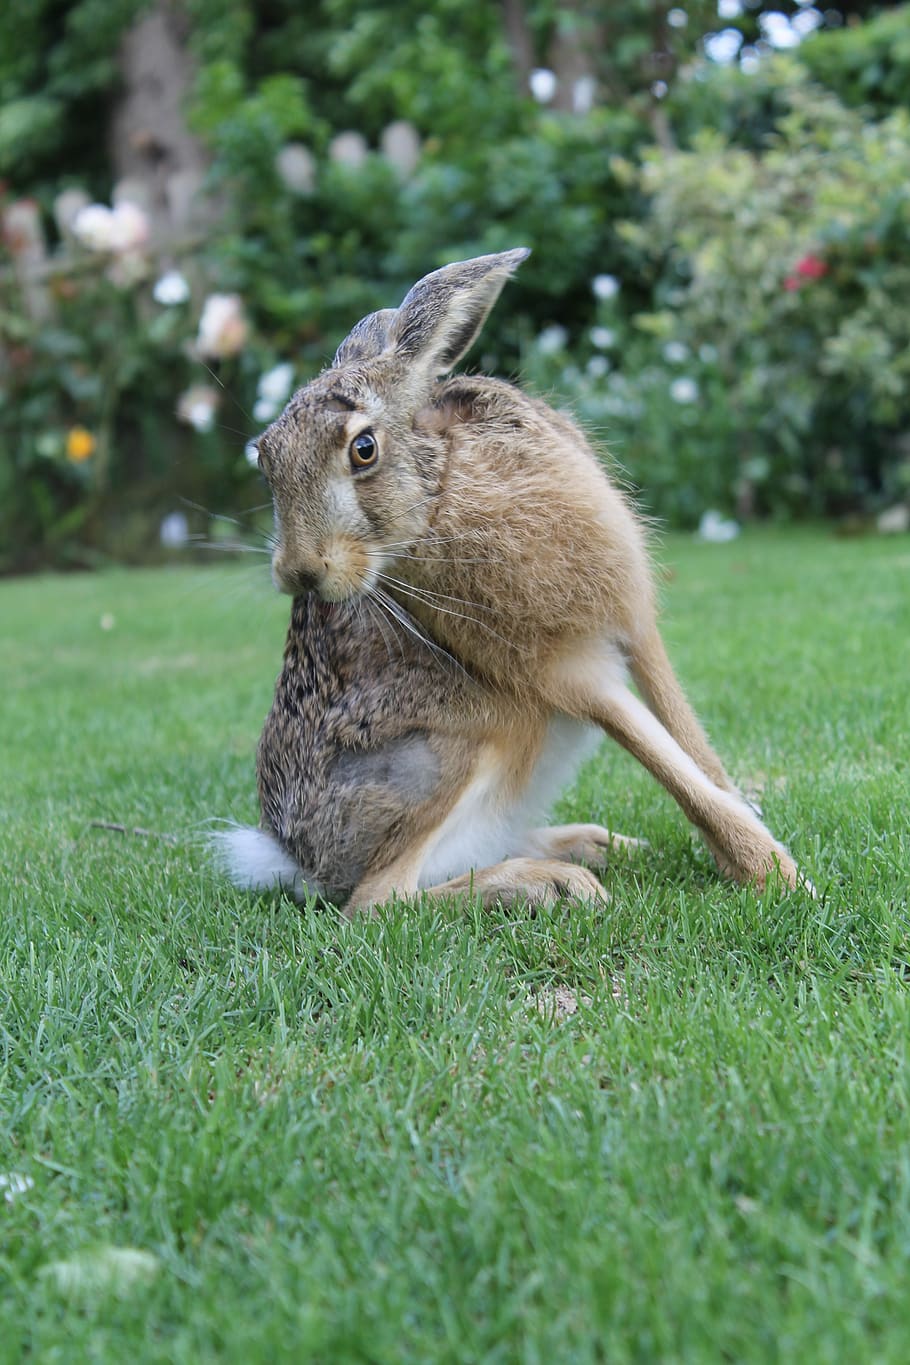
[0,193,281,571]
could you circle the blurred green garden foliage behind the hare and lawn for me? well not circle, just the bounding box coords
[0,0,910,569]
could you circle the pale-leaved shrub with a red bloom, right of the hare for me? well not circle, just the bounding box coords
[529,61,910,526]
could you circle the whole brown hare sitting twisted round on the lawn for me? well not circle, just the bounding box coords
[222,247,799,915]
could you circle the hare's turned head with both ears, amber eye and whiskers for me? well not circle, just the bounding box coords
[258,247,528,602]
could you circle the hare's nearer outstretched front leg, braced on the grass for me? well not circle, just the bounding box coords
[555,654,799,886]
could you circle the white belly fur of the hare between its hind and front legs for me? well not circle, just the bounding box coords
[417,715,603,887]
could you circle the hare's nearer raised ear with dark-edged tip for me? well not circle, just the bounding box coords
[390,247,531,378]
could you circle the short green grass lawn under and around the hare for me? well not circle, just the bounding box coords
[0,532,910,1365]
